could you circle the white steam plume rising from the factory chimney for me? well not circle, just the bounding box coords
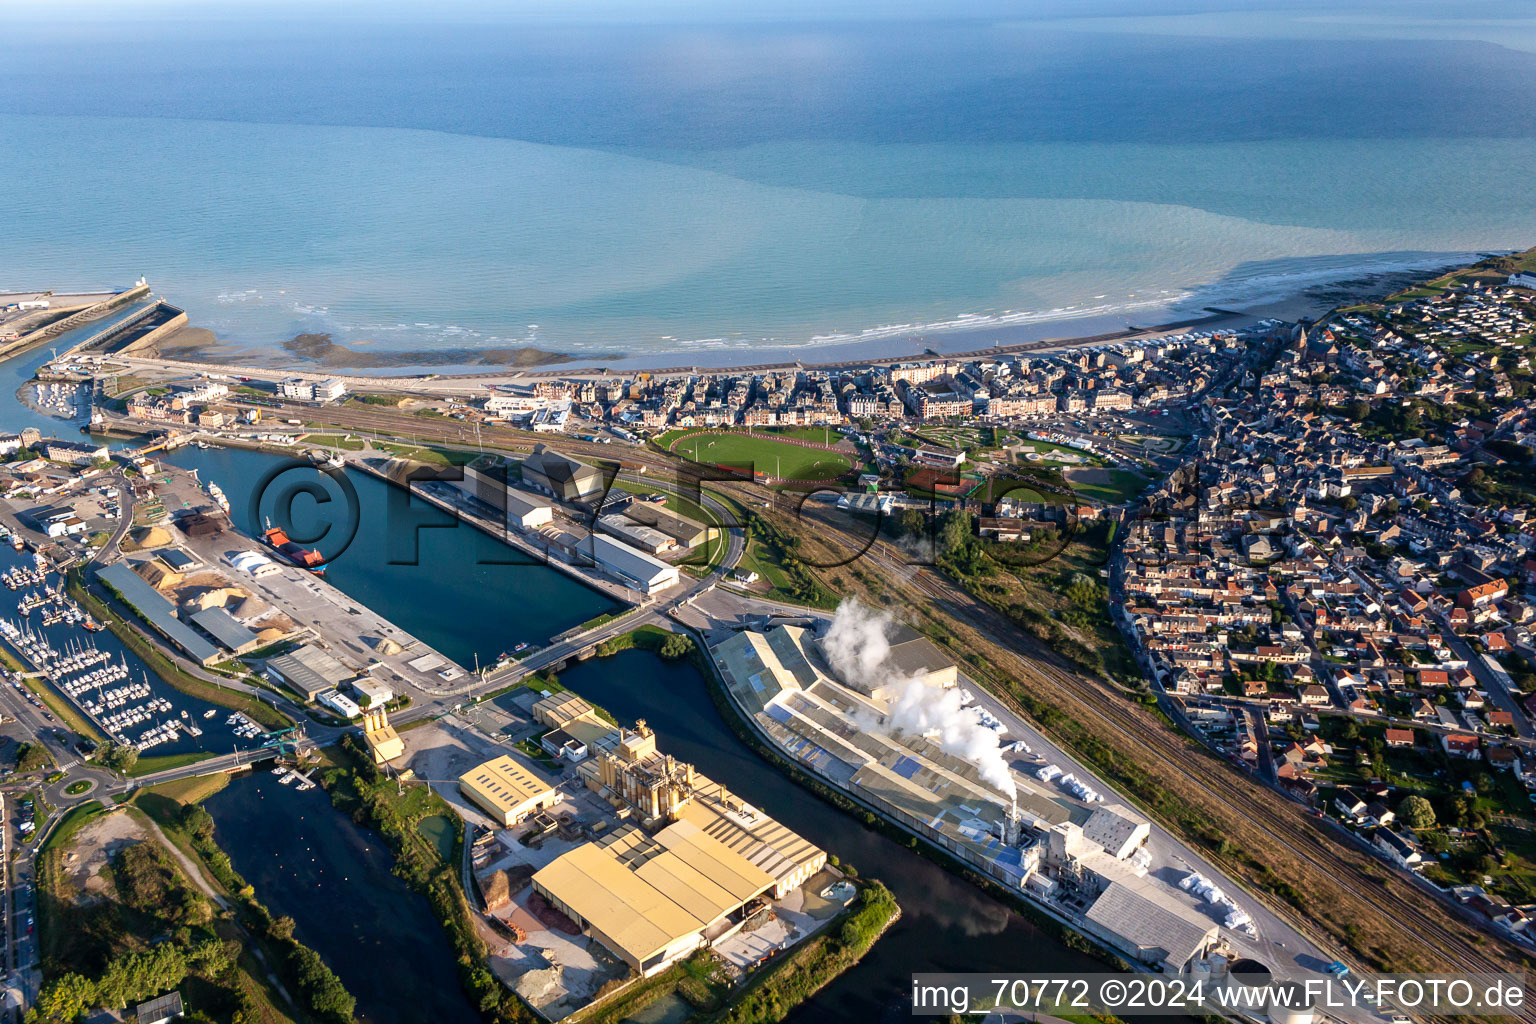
[822,599,1018,800]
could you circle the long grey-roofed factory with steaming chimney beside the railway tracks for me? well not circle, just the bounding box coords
[710,623,1228,973]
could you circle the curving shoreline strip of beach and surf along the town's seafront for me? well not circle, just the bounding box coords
[137,253,1478,381]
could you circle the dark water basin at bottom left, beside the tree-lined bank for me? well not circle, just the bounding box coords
[204,771,481,1024]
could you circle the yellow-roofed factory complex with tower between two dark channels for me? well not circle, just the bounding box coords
[459,706,852,1016]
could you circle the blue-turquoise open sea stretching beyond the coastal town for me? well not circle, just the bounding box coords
[0,0,1536,364]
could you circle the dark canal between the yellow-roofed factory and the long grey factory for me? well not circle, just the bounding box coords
[561,651,1107,1024]
